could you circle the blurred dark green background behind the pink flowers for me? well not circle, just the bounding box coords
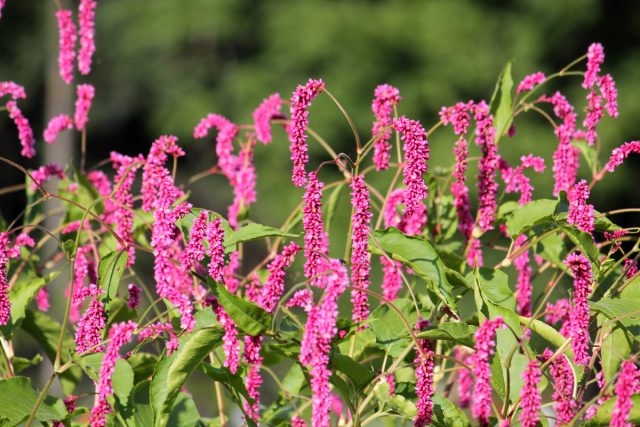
[0,0,640,422]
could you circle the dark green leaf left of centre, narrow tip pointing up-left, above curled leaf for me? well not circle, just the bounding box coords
[207,280,271,336]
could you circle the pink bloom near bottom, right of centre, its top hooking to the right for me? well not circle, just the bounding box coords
[471,317,503,424]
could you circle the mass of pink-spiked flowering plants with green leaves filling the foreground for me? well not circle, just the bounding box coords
[0,0,640,427]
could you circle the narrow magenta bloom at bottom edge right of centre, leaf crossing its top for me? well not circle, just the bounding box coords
[413,321,435,427]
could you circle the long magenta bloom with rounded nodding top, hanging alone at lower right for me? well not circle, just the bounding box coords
[565,253,593,366]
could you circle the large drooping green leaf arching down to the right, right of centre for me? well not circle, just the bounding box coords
[369,227,456,310]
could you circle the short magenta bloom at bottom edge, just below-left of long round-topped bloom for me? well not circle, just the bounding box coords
[542,348,578,426]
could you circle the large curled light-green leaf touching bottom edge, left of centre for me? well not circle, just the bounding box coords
[150,329,221,427]
